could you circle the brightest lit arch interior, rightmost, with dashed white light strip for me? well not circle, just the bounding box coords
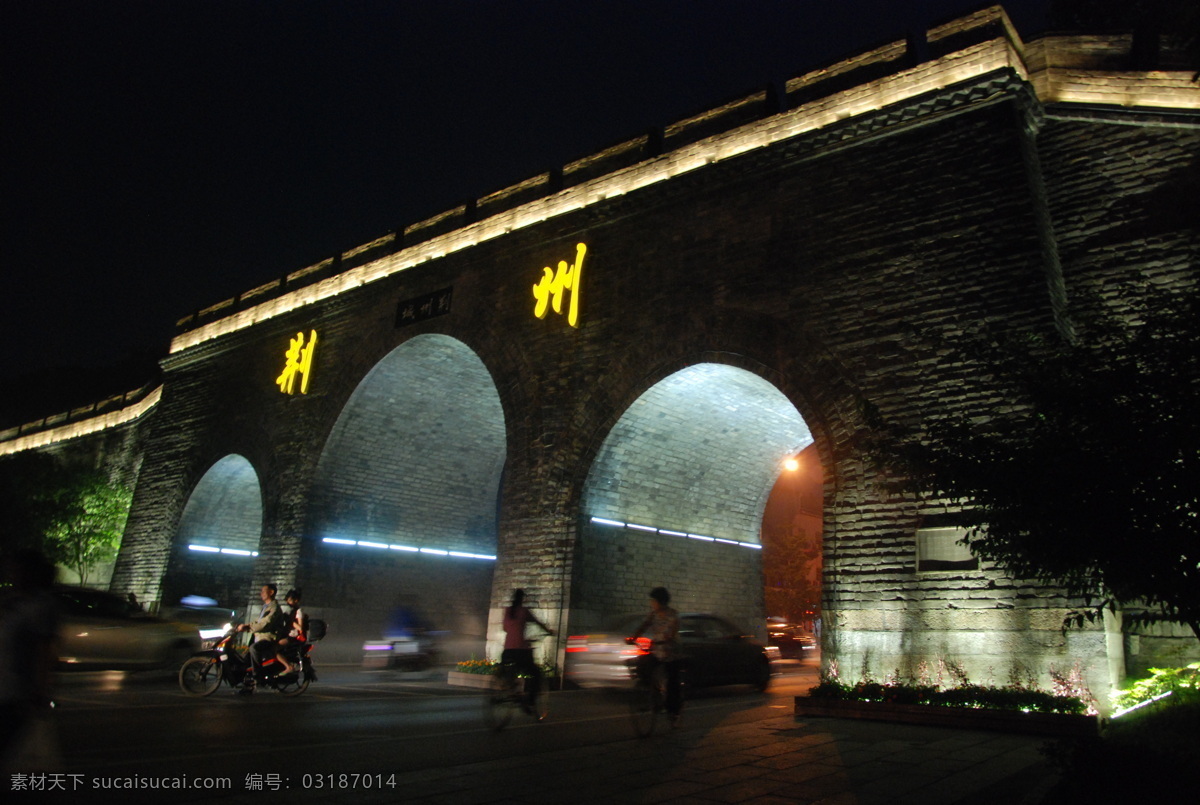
[571,362,812,632]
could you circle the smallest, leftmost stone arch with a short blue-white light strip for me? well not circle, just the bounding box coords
[162,453,263,607]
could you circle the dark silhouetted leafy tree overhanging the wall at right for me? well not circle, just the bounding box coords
[869,290,1200,638]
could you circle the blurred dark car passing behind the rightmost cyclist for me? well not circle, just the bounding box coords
[566,612,770,690]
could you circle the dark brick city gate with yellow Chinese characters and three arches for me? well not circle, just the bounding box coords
[11,8,1200,689]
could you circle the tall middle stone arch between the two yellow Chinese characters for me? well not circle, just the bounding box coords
[302,334,508,651]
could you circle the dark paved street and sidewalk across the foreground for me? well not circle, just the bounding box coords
[4,668,1054,805]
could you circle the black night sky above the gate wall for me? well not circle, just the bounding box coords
[0,0,1046,426]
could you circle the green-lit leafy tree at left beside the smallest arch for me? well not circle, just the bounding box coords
[46,473,133,584]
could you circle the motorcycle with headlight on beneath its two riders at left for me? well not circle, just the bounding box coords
[179,620,325,696]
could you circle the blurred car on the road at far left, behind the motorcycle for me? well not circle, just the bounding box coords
[54,587,200,671]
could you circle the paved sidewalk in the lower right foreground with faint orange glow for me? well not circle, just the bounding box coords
[345,715,1056,805]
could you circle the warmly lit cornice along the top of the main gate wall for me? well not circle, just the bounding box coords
[170,6,1200,354]
